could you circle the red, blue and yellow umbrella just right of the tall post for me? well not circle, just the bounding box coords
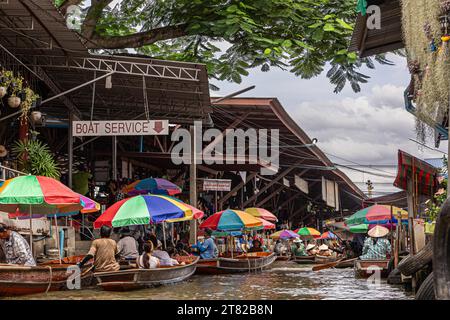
[200,209,263,231]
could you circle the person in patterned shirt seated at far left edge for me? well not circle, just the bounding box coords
[0,224,36,266]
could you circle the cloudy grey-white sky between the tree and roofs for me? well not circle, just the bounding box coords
[211,56,447,165]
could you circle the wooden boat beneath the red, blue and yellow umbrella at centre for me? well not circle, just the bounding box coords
[196,252,277,274]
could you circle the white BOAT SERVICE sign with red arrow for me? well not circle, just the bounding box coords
[72,120,169,137]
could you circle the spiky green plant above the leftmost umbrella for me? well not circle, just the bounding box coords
[12,140,60,179]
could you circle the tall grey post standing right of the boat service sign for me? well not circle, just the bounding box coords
[189,125,197,244]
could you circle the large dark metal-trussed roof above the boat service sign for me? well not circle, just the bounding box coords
[0,0,210,123]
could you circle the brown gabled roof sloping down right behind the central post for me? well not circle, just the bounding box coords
[211,98,366,215]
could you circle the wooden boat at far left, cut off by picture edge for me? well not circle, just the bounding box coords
[0,256,93,296]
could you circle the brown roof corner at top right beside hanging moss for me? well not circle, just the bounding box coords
[349,0,404,57]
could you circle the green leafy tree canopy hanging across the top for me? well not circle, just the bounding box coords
[60,0,390,92]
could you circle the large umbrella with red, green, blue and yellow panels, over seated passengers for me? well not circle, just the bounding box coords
[94,195,193,229]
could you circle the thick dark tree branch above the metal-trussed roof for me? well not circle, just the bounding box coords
[86,24,188,49]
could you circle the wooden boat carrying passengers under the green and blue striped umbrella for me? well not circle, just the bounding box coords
[94,256,199,291]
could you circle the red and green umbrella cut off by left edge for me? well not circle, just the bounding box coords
[0,175,83,214]
